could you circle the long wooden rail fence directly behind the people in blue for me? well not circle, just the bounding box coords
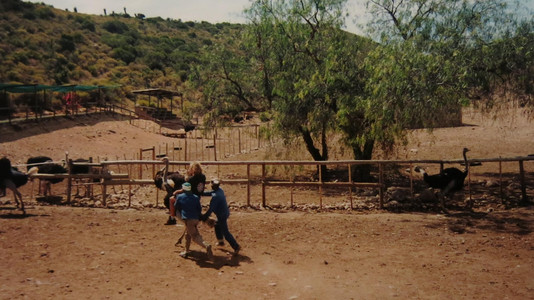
[45,156,534,209]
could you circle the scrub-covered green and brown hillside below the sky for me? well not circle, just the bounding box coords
[0,0,240,93]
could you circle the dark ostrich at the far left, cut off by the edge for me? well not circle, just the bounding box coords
[0,157,37,215]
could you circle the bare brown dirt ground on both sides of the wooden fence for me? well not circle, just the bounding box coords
[0,107,534,299]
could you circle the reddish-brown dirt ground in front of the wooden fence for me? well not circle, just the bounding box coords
[0,206,534,299]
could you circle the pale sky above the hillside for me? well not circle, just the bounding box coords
[25,0,363,33]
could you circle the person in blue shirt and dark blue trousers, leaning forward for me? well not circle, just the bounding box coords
[201,179,241,255]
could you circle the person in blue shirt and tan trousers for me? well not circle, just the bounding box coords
[174,182,213,258]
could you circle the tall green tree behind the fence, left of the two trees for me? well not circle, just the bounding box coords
[246,0,358,164]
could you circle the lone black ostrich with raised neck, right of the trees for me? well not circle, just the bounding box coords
[414,148,469,211]
